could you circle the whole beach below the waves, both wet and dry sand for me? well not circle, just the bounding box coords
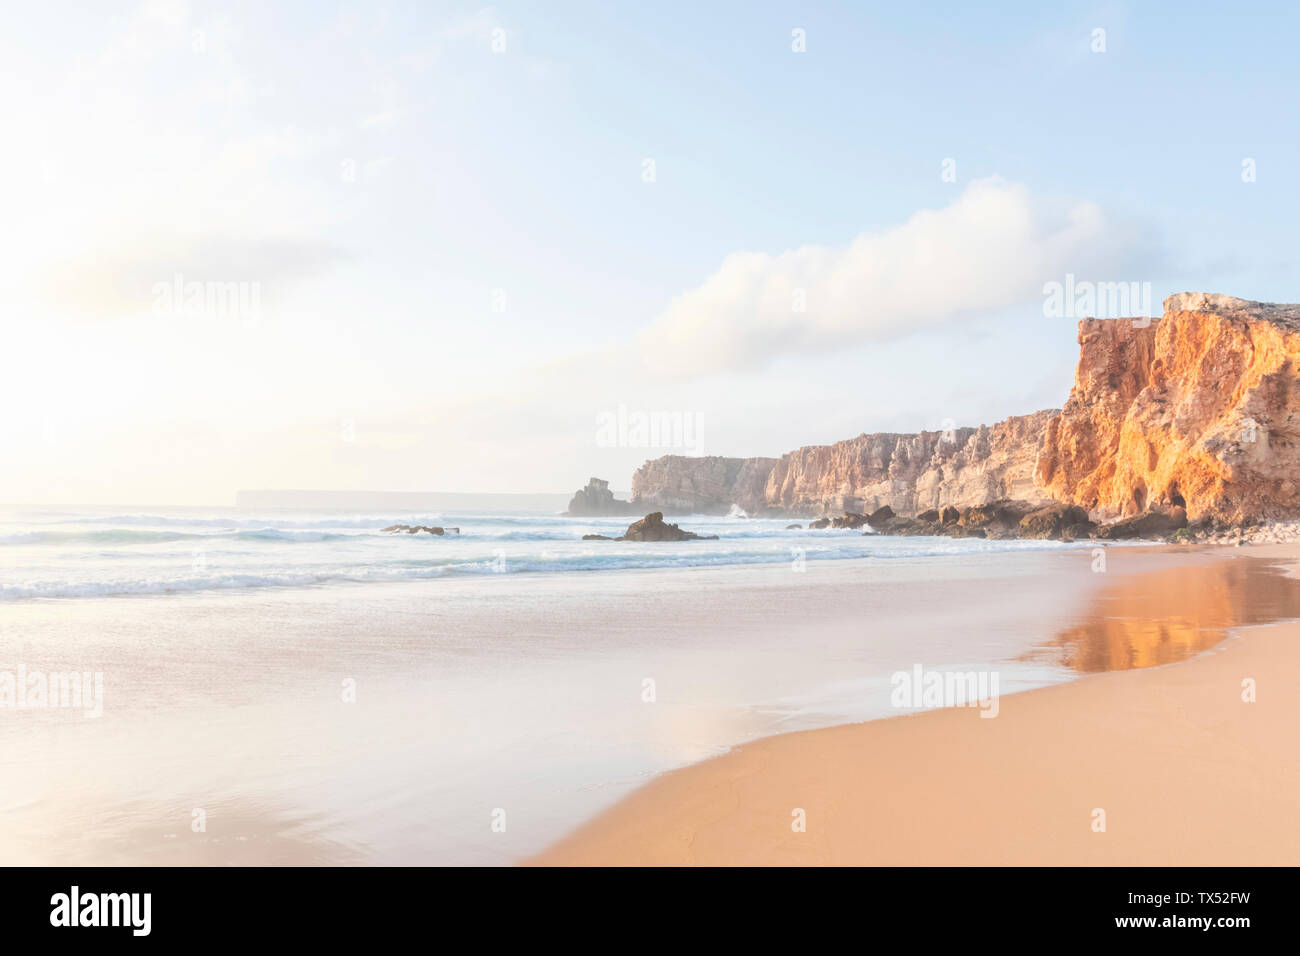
[0,530,1300,865]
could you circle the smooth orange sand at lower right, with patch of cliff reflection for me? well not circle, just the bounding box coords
[532,545,1300,866]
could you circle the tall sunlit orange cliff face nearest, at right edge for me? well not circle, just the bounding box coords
[1036,293,1300,524]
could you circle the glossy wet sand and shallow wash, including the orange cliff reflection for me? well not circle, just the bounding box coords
[0,530,1300,864]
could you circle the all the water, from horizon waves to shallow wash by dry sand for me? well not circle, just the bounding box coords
[0,509,1185,865]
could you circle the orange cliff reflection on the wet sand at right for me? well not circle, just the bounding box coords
[1024,557,1300,674]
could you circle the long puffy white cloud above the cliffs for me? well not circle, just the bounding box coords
[638,178,1153,377]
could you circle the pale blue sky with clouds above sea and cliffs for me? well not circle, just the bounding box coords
[0,0,1300,505]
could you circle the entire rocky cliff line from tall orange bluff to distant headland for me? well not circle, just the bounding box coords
[616,293,1300,524]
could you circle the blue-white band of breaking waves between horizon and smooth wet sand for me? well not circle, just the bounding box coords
[0,509,1107,601]
